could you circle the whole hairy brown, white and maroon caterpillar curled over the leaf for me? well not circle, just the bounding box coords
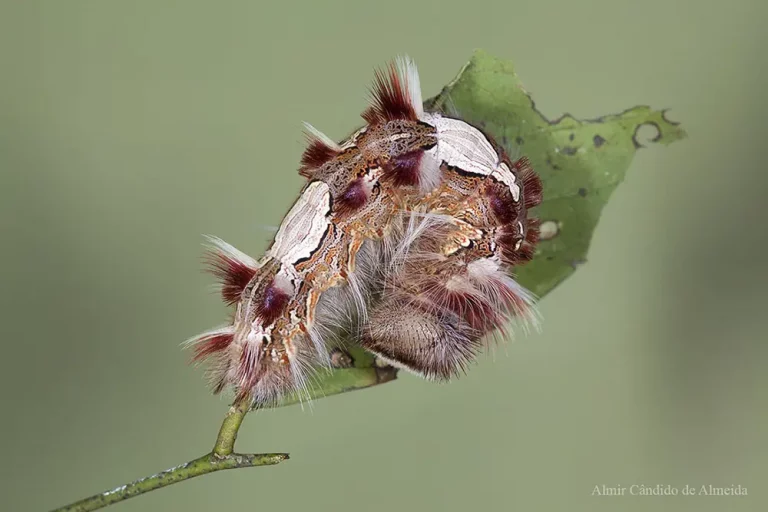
[190,58,541,405]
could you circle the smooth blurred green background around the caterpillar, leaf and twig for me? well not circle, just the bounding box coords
[0,0,768,512]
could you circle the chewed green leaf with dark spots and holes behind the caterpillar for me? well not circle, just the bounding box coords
[272,51,685,404]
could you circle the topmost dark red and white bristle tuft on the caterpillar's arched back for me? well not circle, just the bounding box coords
[362,62,418,125]
